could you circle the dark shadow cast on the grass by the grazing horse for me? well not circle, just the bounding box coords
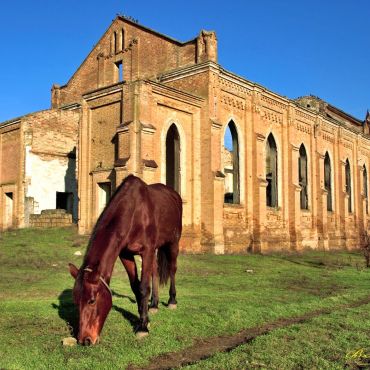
[51,289,139,338]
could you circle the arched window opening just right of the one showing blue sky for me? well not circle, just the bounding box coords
[266,134,278,207]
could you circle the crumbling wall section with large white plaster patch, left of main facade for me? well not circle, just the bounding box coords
[22,109,80,224]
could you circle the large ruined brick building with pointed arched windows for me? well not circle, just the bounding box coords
[0,16,370,253]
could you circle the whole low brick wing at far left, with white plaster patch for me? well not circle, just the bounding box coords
[0,109,80,229]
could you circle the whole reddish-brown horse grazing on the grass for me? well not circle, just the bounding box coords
[69,175,182,345]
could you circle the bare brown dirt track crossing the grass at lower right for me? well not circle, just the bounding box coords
[128,296,370,370]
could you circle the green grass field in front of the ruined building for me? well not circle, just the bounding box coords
[0,229,370,369]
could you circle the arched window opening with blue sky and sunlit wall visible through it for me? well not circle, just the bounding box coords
[223,121,240,204]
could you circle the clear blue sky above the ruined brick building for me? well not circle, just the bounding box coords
[0,0,370,122]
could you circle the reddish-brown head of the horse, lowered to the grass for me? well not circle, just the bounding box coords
[69,263,112,345]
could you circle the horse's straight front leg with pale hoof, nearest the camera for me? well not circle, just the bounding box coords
[136,249,154,337]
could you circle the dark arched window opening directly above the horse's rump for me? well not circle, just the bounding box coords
[166,123,180,193]
